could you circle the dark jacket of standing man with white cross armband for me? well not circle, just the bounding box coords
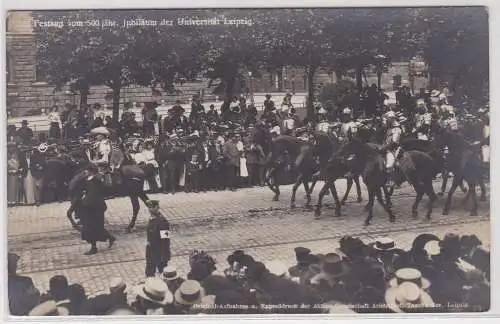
[146,215,170,262]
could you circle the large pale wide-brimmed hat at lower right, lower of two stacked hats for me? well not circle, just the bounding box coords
[385,281,435,313]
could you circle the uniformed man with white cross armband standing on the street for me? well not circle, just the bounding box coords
[145,200,170,277]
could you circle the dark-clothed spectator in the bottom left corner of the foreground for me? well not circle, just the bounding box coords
[7,252,40,316]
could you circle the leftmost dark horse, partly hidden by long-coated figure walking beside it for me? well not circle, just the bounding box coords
[66,144,149,233]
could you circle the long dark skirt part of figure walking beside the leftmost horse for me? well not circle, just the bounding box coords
[78,206,110,243]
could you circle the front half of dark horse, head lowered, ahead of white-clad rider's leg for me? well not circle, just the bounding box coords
[330,138,396,226]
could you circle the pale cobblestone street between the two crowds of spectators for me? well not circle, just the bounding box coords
[8,181,490,294]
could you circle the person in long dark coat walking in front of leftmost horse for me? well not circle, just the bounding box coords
[76,174,116,255]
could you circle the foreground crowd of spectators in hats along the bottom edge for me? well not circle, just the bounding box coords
[8,234,490,316]
